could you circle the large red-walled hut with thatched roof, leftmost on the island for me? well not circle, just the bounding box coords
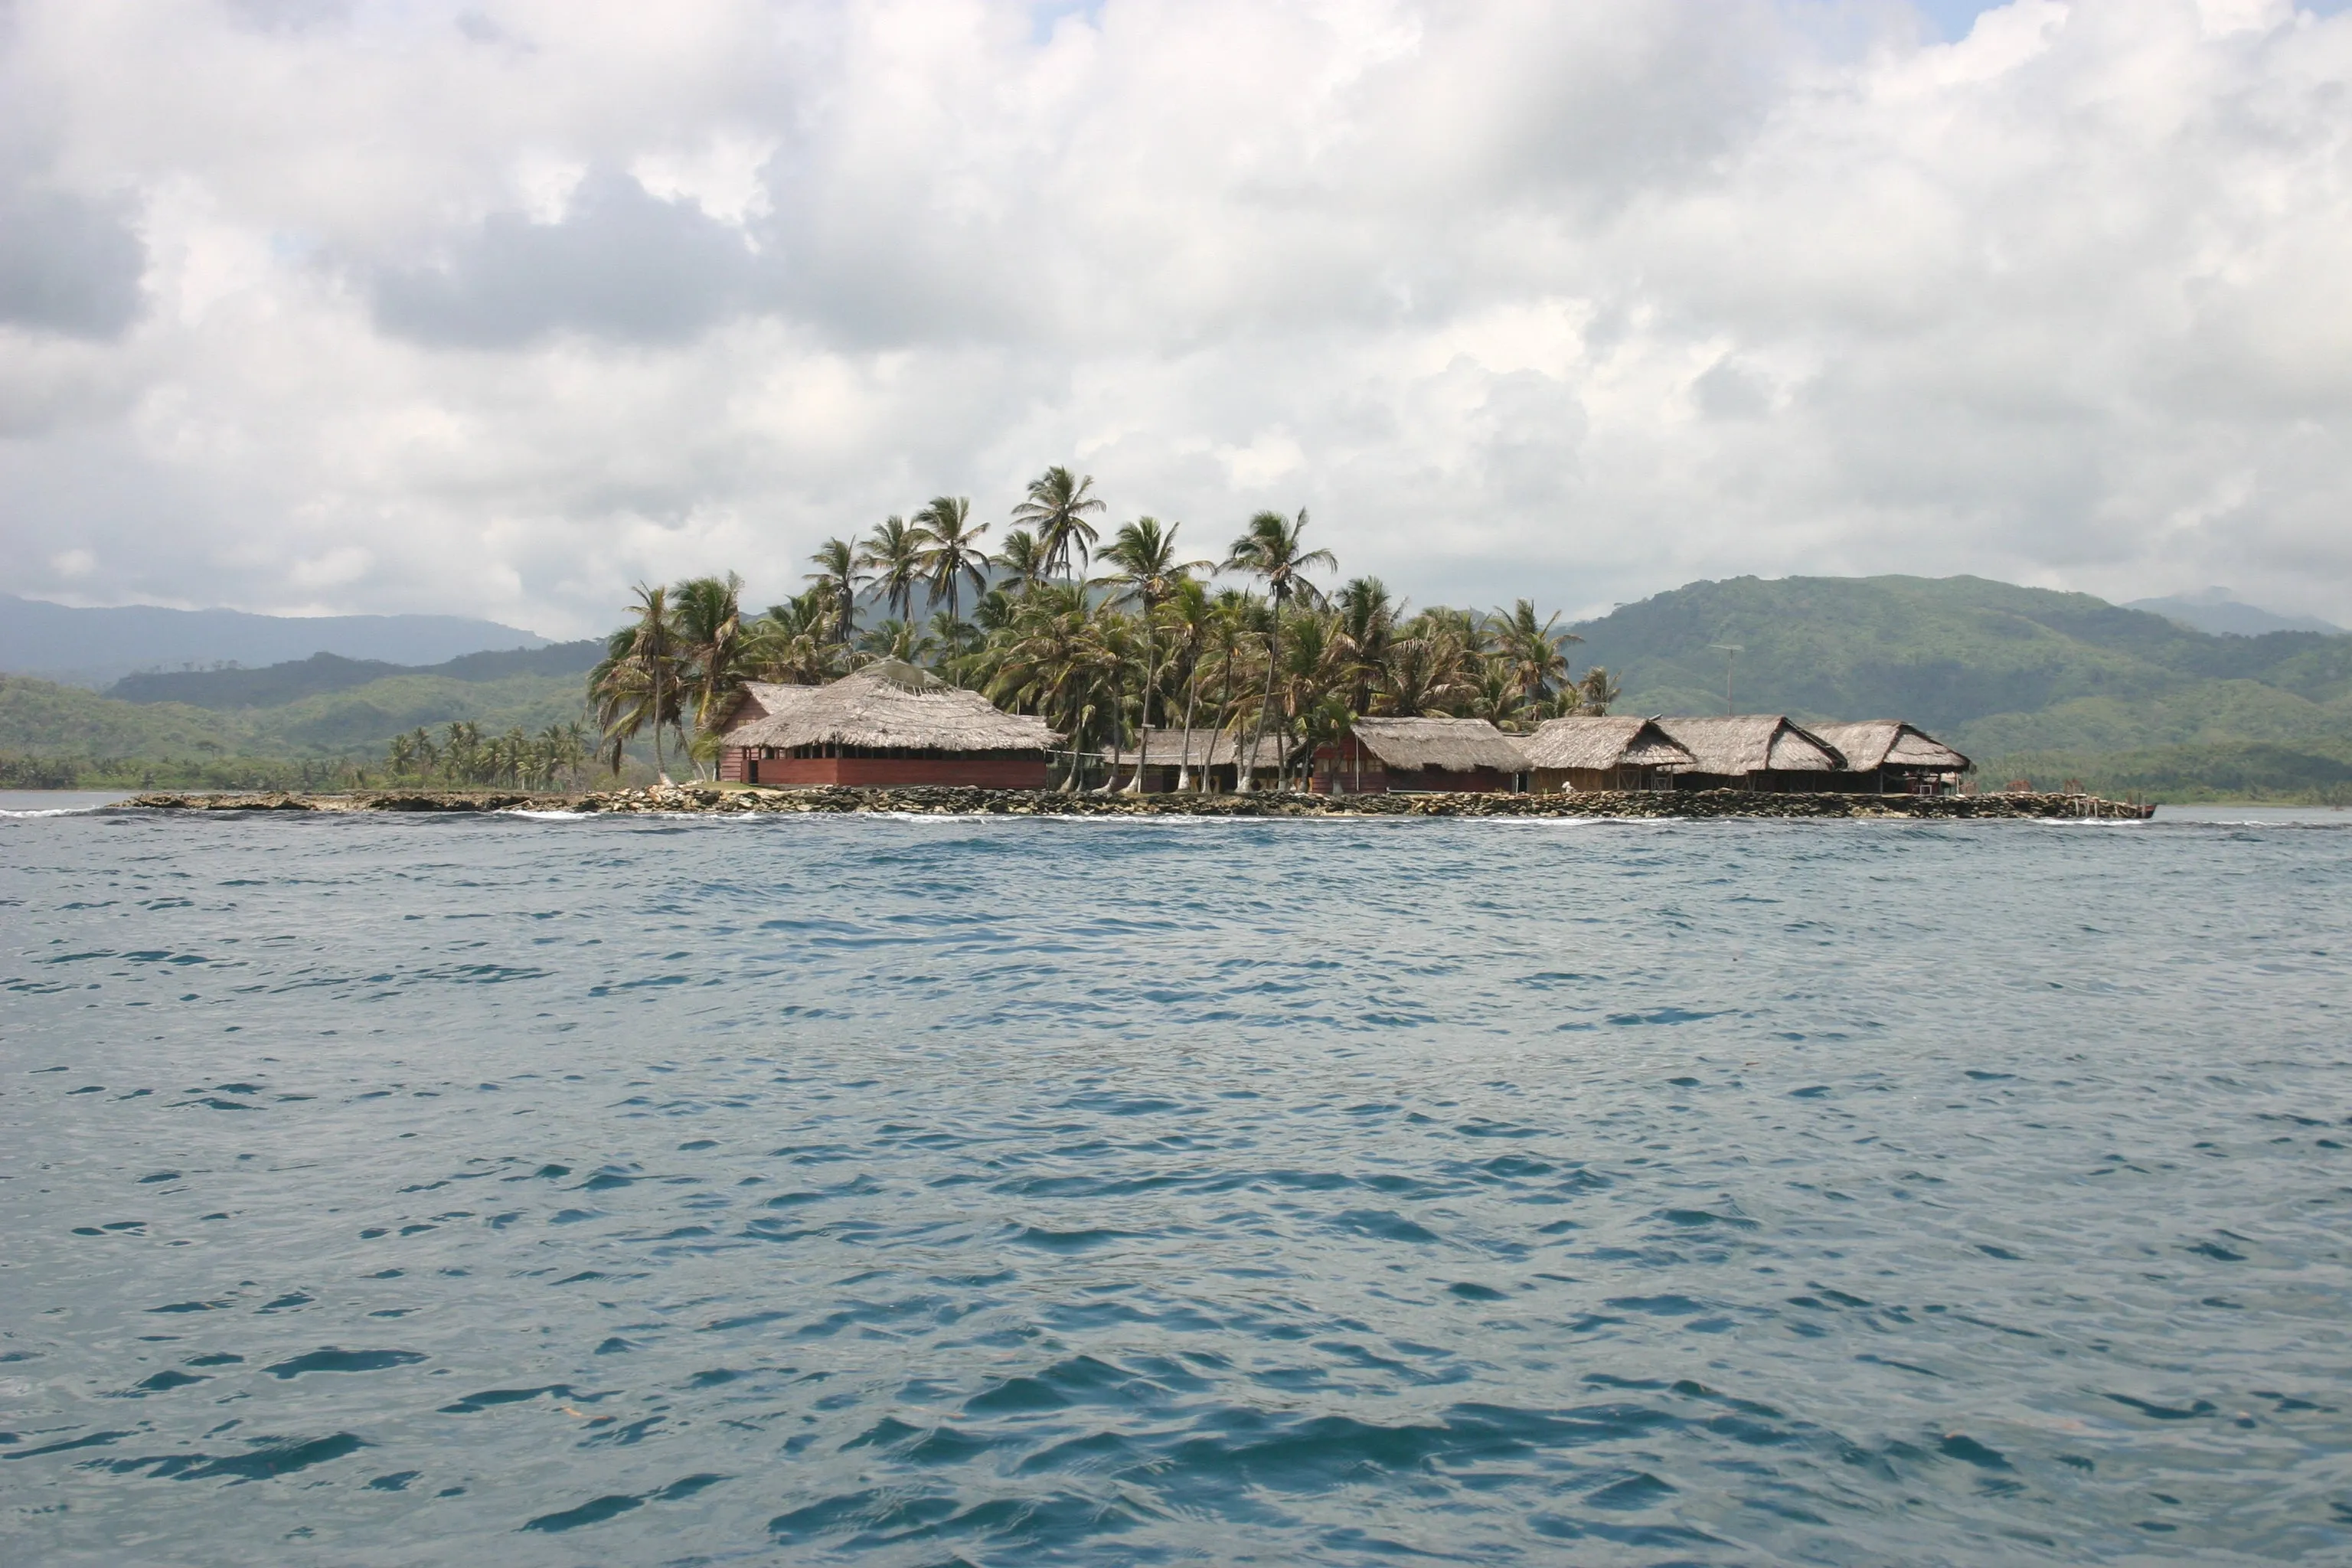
[720,661,1060,790]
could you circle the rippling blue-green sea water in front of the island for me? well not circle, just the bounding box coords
[0,811,2352,1568]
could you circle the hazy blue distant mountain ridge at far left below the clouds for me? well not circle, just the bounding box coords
[0,595,548,687]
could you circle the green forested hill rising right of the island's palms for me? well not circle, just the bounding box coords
[1573,576,2352,792]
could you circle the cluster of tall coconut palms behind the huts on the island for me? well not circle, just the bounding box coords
[588,468,1619,771]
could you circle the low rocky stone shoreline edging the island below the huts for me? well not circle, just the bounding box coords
[122,782,2154,823]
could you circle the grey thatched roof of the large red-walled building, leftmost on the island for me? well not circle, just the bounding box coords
[724,658,1060,753]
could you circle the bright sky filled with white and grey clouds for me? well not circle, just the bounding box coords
[0,0,2352,635]
